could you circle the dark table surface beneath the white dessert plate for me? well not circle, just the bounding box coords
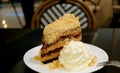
[0,28,120,73]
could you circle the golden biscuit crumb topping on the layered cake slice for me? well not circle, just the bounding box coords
[43,14,80,44]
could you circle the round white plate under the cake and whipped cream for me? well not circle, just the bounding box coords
[23,44,108,73]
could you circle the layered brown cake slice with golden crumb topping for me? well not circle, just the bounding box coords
[40,14,82,63]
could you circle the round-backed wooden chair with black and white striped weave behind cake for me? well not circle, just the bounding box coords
[31,0,96,29]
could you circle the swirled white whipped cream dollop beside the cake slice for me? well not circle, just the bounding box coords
[58,40,94,71]
